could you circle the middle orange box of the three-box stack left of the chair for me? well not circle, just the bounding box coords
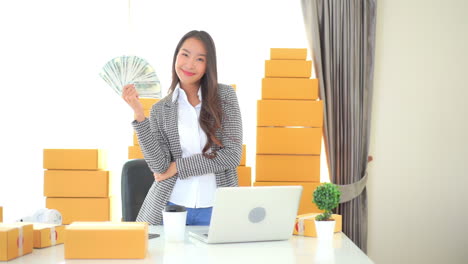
[44,170,109,197]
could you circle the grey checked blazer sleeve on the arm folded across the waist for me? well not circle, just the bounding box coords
[176,84,242,179]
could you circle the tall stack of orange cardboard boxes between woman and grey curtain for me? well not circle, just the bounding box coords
[254,49,323,214]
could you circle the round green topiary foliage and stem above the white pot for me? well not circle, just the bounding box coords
[313,182,341,221]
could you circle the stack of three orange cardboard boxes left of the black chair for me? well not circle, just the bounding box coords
[44,149,111,224]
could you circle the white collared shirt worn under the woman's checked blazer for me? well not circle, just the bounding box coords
[169,84,216,208]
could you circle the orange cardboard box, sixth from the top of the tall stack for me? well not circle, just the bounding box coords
[255,155,320,182]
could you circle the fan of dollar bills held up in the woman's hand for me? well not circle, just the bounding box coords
[99,56,161,98]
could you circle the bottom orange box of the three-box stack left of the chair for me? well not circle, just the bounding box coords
[46,197,111,225]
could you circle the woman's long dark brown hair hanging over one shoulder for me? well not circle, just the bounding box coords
[169,30,223,158]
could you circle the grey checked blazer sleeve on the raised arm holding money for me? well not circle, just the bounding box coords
[132,105,171,173]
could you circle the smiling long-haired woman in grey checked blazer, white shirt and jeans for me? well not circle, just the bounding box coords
[122,30,242,225]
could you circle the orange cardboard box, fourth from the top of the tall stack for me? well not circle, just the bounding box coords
[257,100,323,127]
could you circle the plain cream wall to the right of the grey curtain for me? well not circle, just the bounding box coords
[367,0,468,264]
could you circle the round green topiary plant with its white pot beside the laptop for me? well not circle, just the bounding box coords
[313,182,341,240]
